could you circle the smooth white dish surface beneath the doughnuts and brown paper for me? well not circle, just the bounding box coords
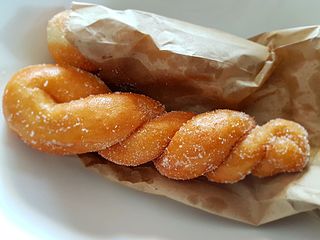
[0,0,320,240]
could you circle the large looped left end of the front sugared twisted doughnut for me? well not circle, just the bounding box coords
[3,65,164,154]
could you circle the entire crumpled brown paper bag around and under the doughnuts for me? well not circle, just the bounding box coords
[67,4,320,225]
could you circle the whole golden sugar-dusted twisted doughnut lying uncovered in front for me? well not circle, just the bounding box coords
[3,65,309,183]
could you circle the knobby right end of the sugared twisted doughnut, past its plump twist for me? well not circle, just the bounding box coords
[206,119,310,183]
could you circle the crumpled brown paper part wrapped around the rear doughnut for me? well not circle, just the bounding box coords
[67,4,275,112]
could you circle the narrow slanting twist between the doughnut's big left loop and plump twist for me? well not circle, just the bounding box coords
[99,112,195,166]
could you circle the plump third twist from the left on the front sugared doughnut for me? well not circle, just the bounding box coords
[154,110,255,180]
